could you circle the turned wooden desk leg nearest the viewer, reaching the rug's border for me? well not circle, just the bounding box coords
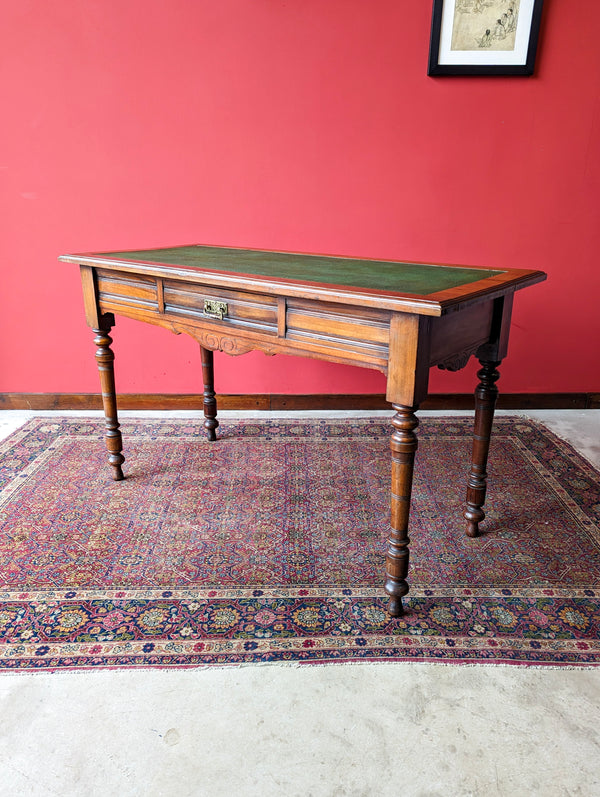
[385,404,419,617]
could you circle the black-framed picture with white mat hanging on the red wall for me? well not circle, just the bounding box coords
[427,0,543,75]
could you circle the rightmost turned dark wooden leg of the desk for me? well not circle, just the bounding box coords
[465,360,500,537]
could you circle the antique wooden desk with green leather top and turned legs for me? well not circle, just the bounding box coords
[60,246,546,617]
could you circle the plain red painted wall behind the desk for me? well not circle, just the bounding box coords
[0,0,600,393]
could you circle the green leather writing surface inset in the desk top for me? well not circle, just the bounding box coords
[88,246,503,296]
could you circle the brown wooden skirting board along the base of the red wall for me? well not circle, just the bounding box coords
[0,393,600,410]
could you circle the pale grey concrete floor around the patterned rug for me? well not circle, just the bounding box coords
[0,410,600,797]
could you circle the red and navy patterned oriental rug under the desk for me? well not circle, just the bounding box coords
[0,417,600,669]
